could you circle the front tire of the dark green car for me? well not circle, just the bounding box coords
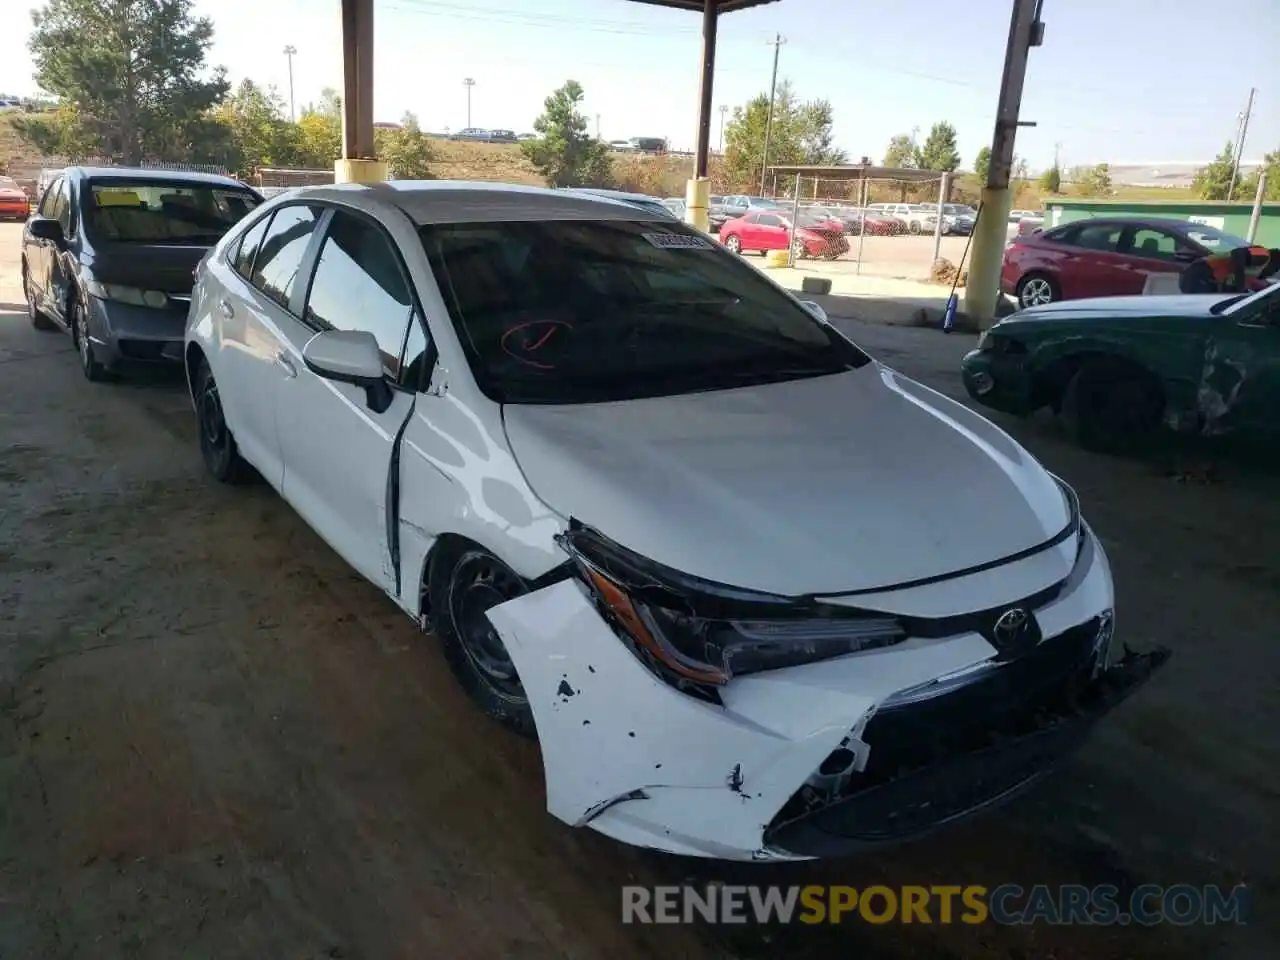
[1061,358,1165,453]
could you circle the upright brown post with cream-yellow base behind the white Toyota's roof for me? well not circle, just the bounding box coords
[333,0,387,183]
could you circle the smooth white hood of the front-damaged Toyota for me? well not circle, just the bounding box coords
[503,364,1070,595]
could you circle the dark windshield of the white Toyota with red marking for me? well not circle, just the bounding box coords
[420,220,869,403]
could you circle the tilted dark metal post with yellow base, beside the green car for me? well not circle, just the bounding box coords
[964,0,1044,325]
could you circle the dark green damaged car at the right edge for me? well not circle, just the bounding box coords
[961,284,1280,453]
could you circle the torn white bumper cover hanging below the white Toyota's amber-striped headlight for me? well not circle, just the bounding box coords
[489,580,995,859]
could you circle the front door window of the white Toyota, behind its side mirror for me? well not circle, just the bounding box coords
[305,212,413,376]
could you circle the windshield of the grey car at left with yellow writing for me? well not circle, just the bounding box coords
[84,179,261,244]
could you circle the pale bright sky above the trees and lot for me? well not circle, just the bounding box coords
[0,0,1280,168]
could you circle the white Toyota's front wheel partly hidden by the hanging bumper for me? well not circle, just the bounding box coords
[428,544,538,740]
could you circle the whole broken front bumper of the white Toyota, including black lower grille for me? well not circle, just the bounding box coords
[489,534,1167,860]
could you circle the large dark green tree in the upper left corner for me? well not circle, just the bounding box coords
[22,0,228,164]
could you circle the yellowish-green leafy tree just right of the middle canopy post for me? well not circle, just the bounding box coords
[724,81,847,191]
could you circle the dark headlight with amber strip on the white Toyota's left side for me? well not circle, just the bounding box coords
[561,529,906,689]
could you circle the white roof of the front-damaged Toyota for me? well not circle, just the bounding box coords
[276,180,671,227]
